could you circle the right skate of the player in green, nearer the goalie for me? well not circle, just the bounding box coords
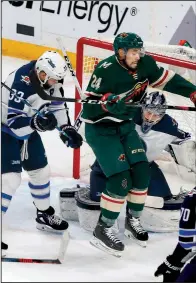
[124,211,148,247]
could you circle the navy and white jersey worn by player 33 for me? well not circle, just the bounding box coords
[2,61,69,140]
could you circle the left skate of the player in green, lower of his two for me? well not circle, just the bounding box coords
[90,220,124,257]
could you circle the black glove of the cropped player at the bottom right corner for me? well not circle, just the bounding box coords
[154,255,184,282]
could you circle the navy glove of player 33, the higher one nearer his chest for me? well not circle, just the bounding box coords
[30,112,57,132]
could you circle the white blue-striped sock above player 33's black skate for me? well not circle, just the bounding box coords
[27,165,50,210]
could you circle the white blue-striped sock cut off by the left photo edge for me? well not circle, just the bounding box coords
[1,173,21,214]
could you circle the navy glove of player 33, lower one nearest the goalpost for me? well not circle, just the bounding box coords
[60,125,83,148]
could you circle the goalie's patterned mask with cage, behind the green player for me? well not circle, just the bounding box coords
[141,91,166,133]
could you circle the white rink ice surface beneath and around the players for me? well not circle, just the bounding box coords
[2,56,194,282]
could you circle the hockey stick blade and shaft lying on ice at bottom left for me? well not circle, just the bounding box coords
[1,230,69,264]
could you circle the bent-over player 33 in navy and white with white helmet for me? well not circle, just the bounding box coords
[1,51,82,253]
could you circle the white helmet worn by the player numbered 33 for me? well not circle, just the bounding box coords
[35,51,67,84]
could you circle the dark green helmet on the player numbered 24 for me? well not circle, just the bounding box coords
[113,32,143,56]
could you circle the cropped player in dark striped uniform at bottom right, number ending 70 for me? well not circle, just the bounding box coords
[154,187,196,282]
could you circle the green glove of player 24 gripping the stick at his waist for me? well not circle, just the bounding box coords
[101,93,127,115]
